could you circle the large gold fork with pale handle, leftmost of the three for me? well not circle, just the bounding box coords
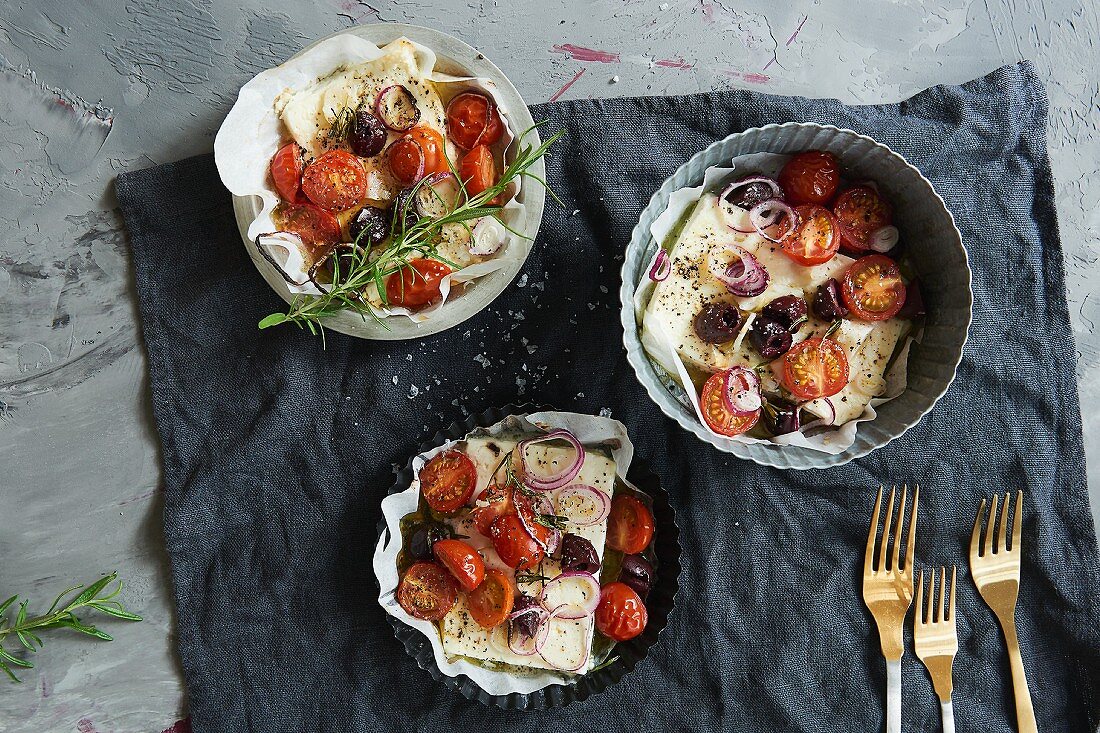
[864,485,921,733]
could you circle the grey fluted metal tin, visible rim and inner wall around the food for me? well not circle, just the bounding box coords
[620,122,974,469]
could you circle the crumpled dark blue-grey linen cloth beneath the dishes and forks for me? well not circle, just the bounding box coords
[118,63,1100,733]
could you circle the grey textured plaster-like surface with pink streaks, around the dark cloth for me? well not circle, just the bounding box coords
[0,0,1100,733]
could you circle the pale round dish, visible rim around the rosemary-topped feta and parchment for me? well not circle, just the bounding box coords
[233,23,546,340]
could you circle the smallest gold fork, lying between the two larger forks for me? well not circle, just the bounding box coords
[913,566,959,733]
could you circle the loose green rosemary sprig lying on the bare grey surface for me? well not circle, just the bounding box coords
[0,572,142,682]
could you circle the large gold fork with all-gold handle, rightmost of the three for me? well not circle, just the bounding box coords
[970,491,1036,733]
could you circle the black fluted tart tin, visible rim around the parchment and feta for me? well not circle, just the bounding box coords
[375,404,680,710]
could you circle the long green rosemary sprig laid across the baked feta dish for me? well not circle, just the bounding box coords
[260,125,564,335]
